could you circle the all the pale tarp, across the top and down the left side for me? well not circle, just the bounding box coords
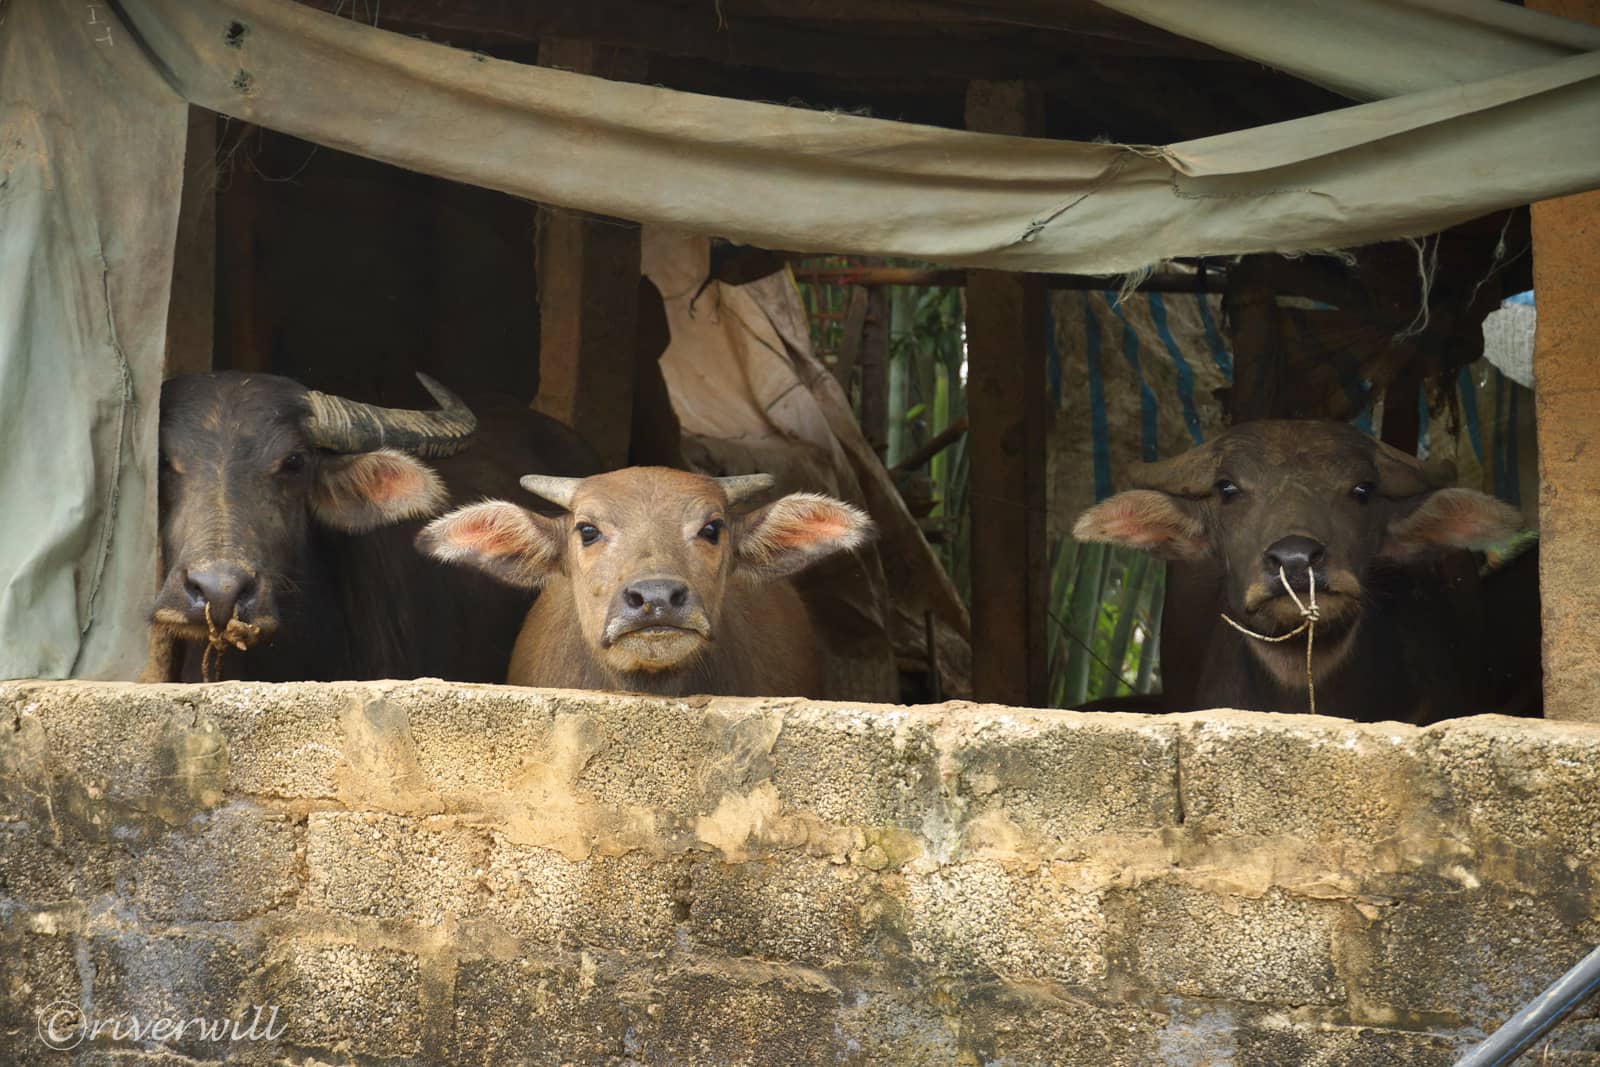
[0,0,1600,677]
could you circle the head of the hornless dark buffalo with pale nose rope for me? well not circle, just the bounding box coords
[1074,421,1522,677]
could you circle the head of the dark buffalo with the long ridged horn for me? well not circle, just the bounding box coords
[150,373,475,649]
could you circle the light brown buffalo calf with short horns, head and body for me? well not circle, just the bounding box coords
[418,467,870,696]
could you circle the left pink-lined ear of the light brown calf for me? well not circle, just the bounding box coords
[416,501,562,589]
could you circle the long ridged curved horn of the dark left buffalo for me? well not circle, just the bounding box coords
[306,373,478,458]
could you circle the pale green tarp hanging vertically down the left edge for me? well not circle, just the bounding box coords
[0,0,186,678]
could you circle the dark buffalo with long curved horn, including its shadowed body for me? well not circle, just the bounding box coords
[150,373,598,681]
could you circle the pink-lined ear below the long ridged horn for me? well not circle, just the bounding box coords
[310,448,448,533]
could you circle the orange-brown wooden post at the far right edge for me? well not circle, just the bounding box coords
[1528,0,1600,721]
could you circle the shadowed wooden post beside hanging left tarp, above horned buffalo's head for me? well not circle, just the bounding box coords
[163,106,218,378]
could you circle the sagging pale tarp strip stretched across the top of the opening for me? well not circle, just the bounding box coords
[122,0,1600,274]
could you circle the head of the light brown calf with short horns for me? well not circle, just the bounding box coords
[418,467,870,673]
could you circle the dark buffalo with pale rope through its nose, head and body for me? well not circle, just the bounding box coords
[1074,421,1538,721]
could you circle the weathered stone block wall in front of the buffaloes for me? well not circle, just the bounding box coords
[0,683,1600,1067]
